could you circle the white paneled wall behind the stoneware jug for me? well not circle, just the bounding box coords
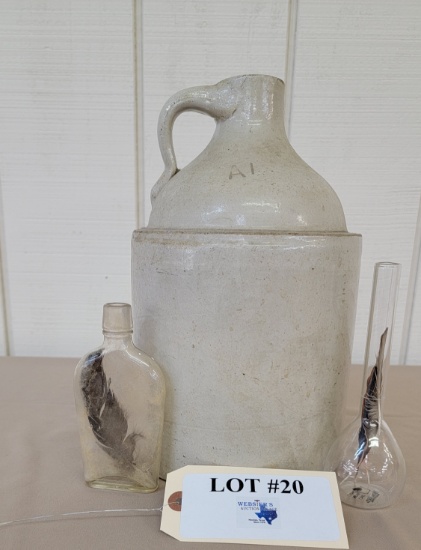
[0,0,421,364]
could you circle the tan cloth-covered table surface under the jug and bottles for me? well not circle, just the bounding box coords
[0,357,421,550]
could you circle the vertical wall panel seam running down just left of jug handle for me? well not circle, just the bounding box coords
[132,0,146,228]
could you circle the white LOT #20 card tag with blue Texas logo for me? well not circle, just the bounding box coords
[161,466,349,548]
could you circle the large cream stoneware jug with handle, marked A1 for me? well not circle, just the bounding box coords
[132,75,361,477]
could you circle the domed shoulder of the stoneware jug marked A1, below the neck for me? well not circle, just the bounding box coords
[149,146,347,232]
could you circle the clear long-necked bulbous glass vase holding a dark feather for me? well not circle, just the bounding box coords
[324,262,406,509]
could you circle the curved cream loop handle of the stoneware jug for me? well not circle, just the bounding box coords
[151,84,237,201]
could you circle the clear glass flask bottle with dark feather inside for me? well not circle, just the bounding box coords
[74,303,165,493]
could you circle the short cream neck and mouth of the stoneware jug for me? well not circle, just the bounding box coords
[221,75,286,135]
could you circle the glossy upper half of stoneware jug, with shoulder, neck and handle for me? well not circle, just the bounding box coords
[148,75,346,232]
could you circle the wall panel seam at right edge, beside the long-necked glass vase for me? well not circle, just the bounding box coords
[399,197,421,365]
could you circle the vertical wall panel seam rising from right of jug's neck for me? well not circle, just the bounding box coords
[284,0,298,138]
